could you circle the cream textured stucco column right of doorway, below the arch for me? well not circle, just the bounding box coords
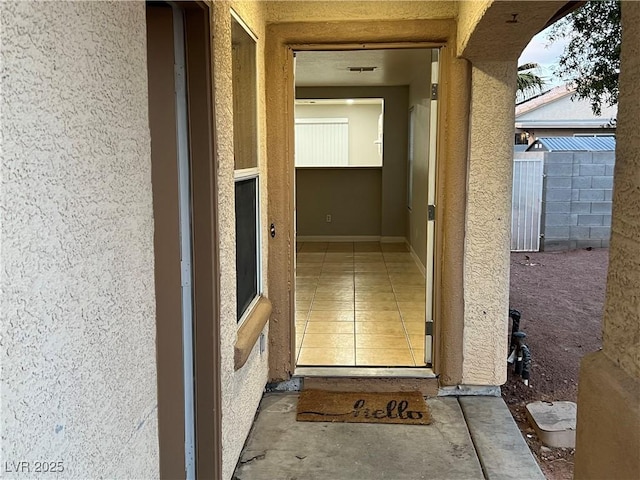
[462,62,516,385]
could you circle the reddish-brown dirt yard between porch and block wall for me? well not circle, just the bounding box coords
[502,249,609,480]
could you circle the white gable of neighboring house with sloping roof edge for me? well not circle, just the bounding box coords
[515,85,618,129]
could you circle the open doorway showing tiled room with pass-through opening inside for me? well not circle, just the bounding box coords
[295,48,438,368]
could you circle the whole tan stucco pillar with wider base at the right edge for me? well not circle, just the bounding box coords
[574,2,640,479]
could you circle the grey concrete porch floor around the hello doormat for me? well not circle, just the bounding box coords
[234,393,544,480]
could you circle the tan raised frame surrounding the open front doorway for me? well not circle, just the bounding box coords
[265,20,470,382]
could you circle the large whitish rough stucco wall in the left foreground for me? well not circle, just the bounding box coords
[0,2,159,478]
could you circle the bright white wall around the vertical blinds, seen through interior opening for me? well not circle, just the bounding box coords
[295,103,382,166]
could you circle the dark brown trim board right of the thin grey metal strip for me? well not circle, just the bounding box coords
[180,2,222,479]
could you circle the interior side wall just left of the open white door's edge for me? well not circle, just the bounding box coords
[407,62,431,267]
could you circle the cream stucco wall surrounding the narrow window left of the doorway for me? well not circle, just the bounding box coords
[212,2,269,479]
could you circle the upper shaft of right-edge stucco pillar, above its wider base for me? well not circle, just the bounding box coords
[603,2,640,380]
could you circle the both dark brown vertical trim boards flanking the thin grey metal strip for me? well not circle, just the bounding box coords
[147,2,222,479]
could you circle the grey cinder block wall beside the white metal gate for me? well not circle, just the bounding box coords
[540,152,615,251]
